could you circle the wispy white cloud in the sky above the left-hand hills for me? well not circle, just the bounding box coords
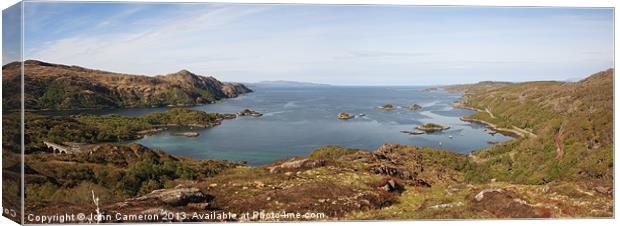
[25,4,267,74]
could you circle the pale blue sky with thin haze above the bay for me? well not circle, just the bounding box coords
[3,2,614,85]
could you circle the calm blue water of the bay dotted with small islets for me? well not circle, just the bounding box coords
[74,86,510,165]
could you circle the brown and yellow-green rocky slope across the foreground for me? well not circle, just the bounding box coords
[23,144,613,222]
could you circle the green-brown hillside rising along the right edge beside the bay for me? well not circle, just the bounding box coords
[456,70,613,186]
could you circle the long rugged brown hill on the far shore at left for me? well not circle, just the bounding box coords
[2,60,252,110]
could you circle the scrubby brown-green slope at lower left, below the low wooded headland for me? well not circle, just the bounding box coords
[26,144,236,207]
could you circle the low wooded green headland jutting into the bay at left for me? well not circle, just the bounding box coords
[10,108,231,153]
